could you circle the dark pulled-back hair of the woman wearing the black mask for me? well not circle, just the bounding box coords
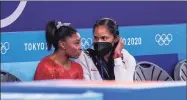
[93,18,119,36]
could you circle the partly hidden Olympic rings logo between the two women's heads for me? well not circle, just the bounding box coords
[81,38,92,49]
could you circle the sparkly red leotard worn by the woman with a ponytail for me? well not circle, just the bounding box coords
[34,57,83,80]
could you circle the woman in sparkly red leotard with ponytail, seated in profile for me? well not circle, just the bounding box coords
[34,21,83,80]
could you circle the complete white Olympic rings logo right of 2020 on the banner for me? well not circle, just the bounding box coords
[155,34,173,46]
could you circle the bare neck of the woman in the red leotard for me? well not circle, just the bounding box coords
[53,51,70,67]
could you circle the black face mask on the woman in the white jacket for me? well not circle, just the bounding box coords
[93,42,113,57]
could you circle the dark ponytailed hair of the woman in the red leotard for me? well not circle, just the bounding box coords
[45,20,77,51]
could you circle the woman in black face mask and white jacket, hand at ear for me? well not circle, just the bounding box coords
[77,18,136,81]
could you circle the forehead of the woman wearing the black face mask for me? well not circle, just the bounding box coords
[94,26,112,37]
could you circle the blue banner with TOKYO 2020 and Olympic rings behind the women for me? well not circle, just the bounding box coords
[1,24,186,62]
